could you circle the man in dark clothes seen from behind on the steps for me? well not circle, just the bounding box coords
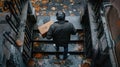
[46,11,76,60]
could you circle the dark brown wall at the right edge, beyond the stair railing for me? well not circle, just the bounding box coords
[107,0,120,66]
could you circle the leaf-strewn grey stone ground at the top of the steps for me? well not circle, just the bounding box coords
[32,0,86,16]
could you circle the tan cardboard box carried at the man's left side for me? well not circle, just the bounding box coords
[38,21,53,37]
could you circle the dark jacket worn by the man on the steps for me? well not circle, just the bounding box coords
[47,21,76,45]
